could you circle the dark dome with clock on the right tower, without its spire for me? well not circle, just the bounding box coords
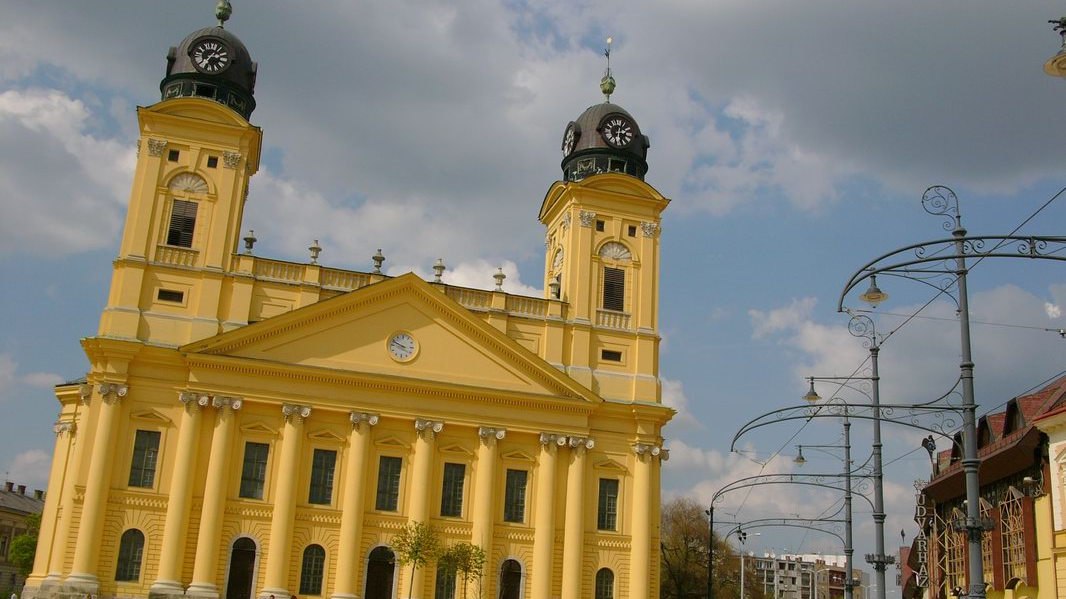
[562,102,651,180]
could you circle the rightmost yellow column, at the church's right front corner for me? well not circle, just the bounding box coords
[629,443,662,599]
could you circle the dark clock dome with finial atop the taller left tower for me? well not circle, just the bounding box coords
[159,0,257,118]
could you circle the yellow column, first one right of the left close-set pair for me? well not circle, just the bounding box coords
[259,404,311,599]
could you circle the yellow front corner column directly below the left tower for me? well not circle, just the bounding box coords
[66,383,129,595]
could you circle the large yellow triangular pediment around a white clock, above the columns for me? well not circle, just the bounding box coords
[181,274,601,403]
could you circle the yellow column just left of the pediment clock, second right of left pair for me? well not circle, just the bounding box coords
[330,411,378,599]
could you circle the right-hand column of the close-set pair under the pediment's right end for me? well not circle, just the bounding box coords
[562,436,596,599]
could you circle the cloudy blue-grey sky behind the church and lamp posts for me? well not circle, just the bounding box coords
[0,0,1066,580]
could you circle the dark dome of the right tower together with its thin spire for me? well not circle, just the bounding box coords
[562,38,651,181]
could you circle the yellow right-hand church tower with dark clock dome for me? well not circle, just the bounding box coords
[539,69,669,403]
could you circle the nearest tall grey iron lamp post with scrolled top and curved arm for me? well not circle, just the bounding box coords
[837,185,1066,599]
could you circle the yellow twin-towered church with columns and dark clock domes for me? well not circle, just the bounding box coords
[23,0,673,599]
